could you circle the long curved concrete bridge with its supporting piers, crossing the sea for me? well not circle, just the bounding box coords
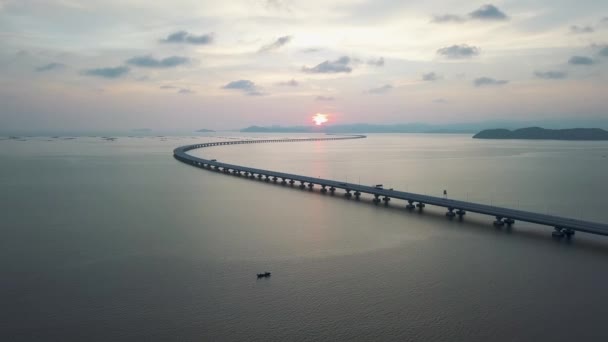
[173,135,608,238]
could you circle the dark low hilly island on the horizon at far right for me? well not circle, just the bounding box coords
[473,127,608,140]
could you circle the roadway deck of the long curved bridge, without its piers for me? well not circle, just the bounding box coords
[173,136,608,235]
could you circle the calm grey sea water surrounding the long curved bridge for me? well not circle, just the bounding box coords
[0,134,608,341]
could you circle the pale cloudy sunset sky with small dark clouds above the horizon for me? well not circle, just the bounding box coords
[0,0,608,131]
